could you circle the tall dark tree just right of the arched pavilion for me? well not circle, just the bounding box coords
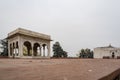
[53,42,67,58]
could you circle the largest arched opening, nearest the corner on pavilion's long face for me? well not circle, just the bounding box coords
[23,41,32,56]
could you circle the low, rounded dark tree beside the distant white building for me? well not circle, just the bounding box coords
[79,48,93,58]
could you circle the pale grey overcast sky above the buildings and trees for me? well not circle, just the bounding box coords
[0,0,120,56]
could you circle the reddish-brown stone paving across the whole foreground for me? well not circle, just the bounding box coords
[0,59,120,80]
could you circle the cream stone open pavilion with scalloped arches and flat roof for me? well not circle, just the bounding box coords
[7,28,52,58]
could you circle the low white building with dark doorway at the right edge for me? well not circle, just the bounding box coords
[94,45,120,58]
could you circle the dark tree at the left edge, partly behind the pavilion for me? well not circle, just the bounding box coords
[0,38,8,56]
